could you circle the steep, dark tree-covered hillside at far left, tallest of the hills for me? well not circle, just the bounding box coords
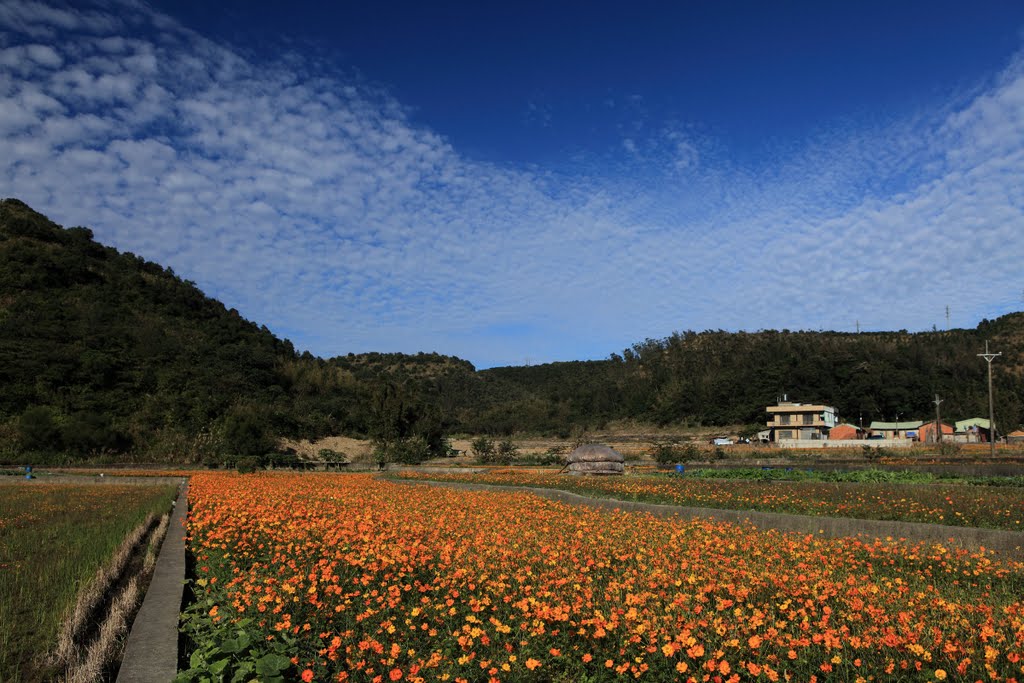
[0,200,298,460]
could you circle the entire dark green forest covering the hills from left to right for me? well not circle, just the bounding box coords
[0,200,1024,462]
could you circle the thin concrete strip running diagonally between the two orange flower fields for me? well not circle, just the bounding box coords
[385,477,1024,561]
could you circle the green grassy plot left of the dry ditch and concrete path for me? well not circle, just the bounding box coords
[0,481,175,683]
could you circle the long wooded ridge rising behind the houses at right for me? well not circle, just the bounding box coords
[468,321,1024,432]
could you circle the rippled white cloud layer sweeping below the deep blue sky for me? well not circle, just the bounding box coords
[0,0,1024,365]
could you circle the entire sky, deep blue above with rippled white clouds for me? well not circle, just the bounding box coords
[0,0,1024,367]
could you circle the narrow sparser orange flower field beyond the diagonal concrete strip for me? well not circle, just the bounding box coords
[398,469,1024,531]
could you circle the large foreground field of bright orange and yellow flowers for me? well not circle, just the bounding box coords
[179,474,1024,683]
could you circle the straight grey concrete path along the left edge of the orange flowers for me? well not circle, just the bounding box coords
[117,479,188,683]
